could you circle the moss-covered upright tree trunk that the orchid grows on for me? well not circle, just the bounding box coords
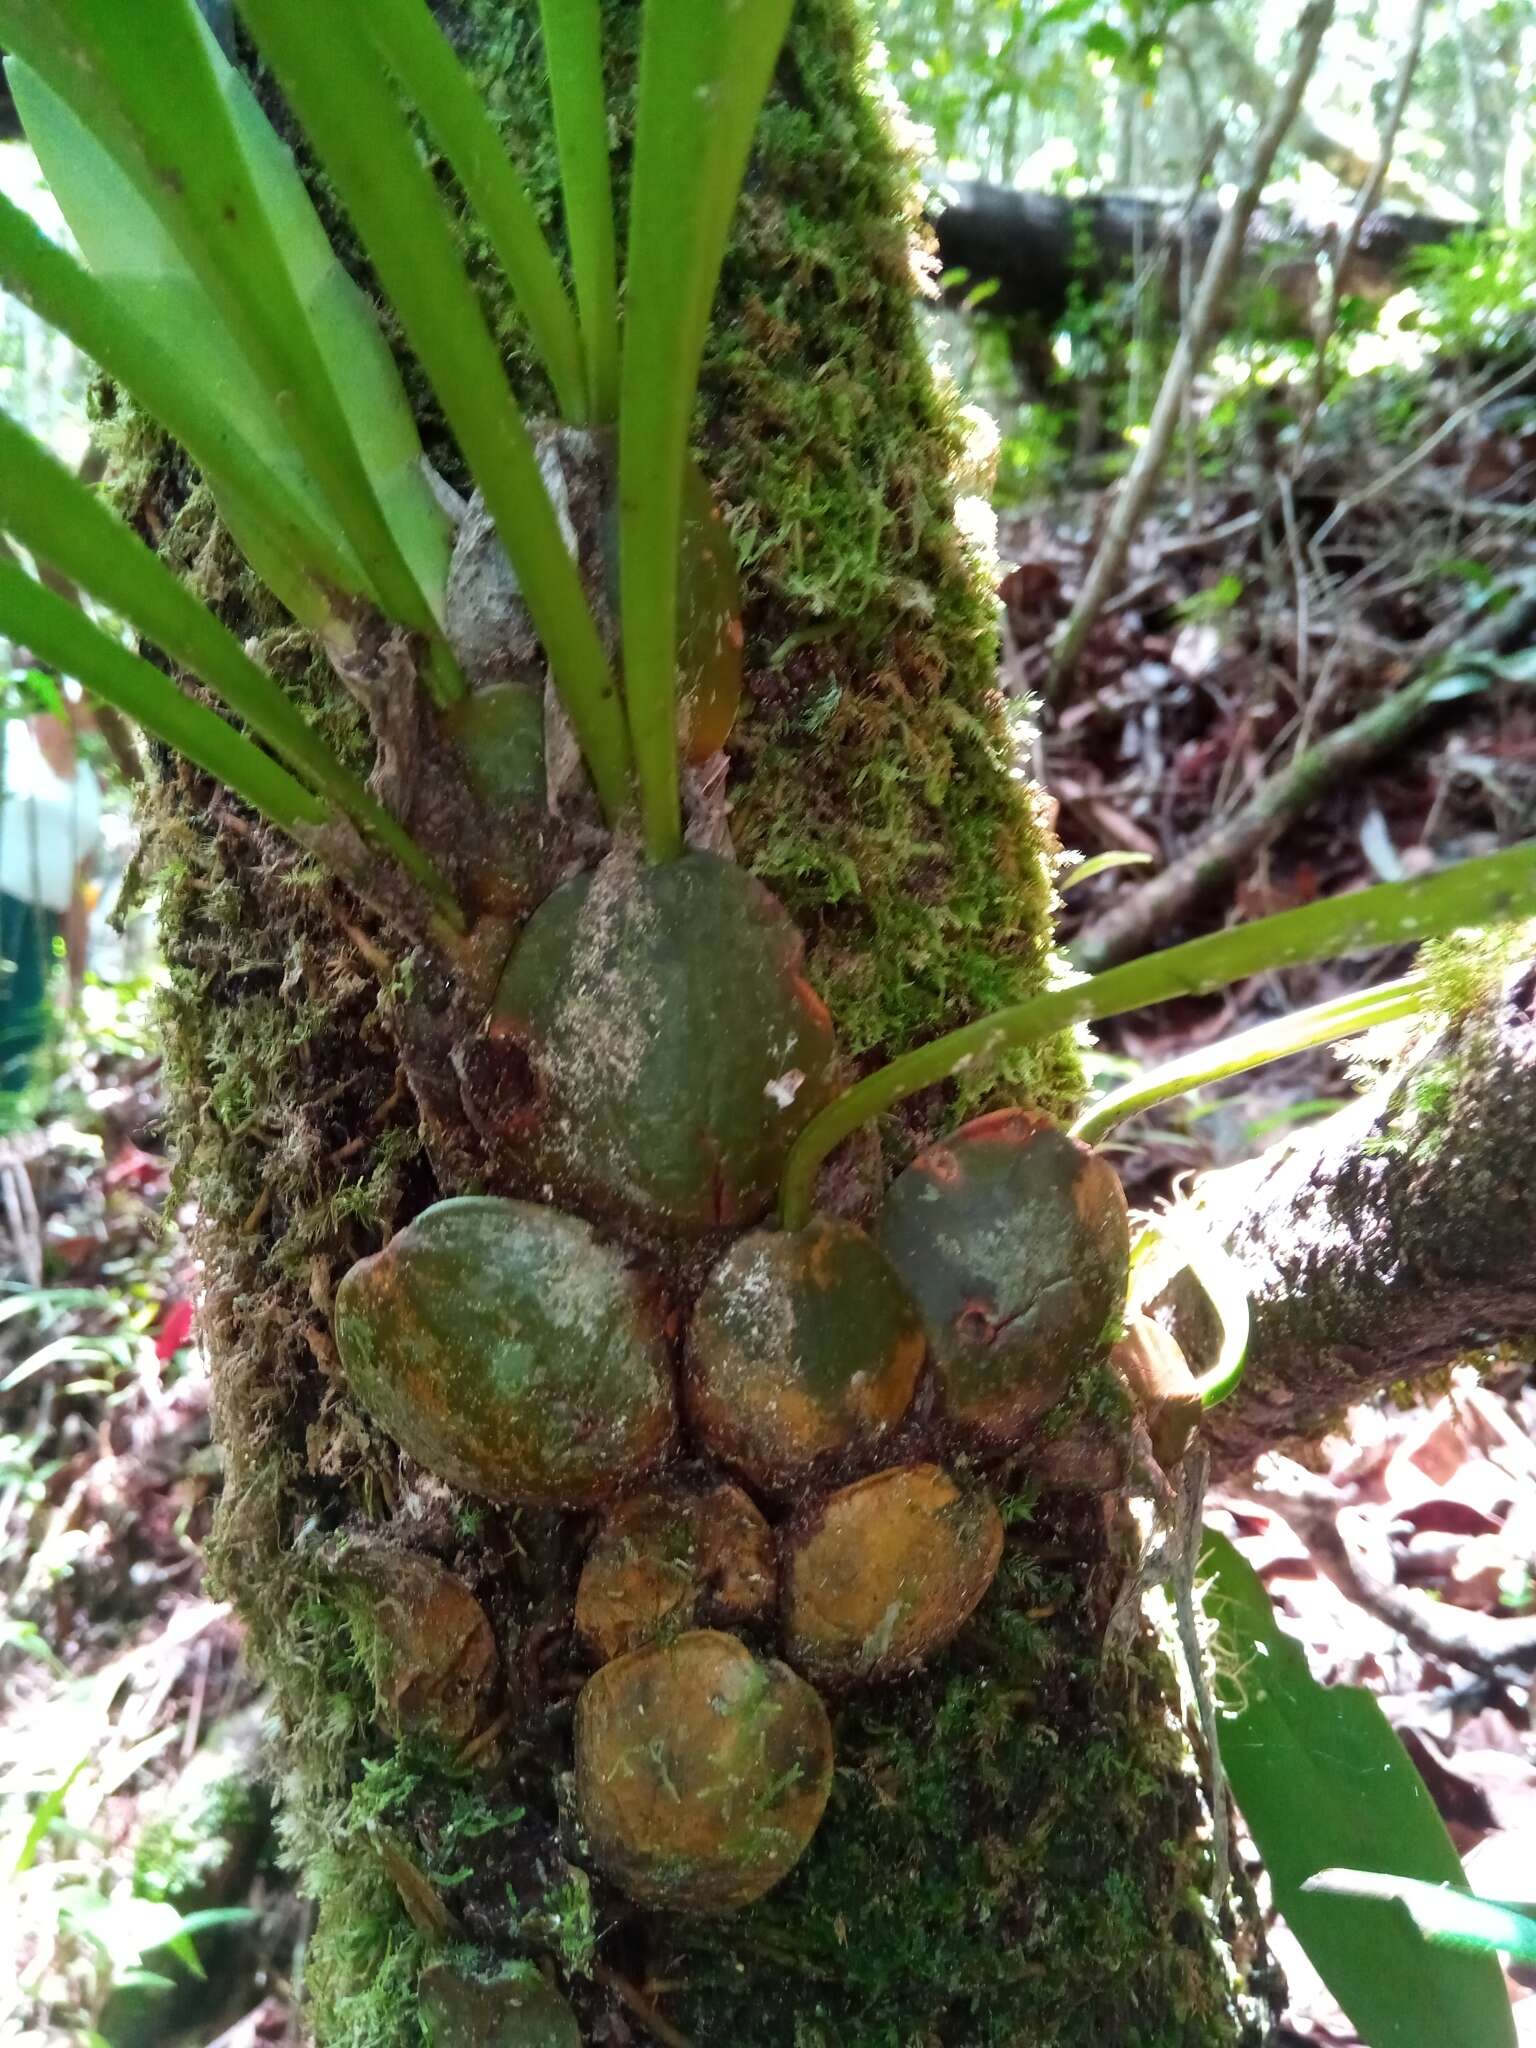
[138,0,1262,2048]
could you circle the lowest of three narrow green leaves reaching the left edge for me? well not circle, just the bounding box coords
[0,561,332,831]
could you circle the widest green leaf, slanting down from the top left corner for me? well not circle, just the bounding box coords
[0,0,449,671]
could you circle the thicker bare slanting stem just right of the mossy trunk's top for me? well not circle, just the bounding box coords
[1047,0,1333,702]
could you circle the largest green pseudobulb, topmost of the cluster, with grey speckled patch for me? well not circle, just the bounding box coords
[489,850,831,1231]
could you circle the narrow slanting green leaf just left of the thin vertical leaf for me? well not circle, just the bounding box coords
[358,0,593,426]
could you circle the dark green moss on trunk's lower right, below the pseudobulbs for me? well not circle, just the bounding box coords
[670,1528,1257,2048]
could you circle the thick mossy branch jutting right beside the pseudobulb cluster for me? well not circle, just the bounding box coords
[1198,965,1536,1470]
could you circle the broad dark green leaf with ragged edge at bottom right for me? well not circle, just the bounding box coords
[1200,1530,1516,2048]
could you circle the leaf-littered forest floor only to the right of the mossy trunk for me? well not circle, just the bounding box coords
[999,364,1536,2048]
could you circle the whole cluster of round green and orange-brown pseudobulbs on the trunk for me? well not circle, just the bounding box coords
[334,852,1196,1911]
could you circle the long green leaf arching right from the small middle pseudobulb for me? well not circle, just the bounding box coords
[780,840,1536,1231]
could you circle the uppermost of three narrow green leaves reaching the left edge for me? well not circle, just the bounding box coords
[0,195,362,623]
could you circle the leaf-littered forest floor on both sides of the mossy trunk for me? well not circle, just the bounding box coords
[0,372,1536,2048]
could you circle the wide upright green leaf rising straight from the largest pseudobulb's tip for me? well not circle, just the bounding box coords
[618,0,791,860]
